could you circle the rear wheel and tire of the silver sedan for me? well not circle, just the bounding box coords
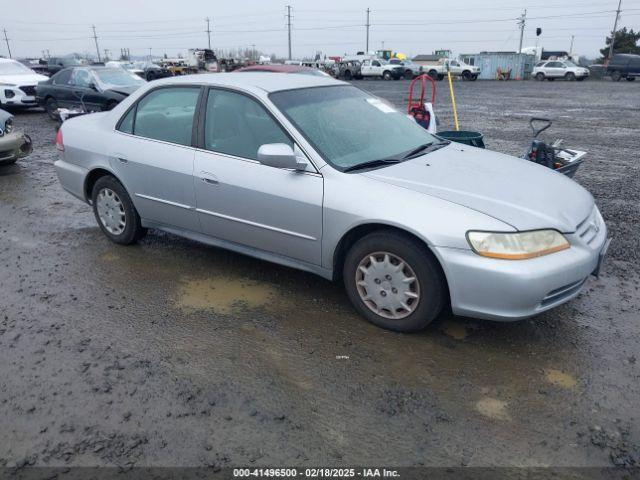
[91,175,147,245]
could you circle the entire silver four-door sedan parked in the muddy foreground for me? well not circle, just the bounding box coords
[56,72,608,331]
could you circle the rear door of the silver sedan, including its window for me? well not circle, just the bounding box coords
[110,86,201,231]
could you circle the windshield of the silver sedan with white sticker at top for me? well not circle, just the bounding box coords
[269,86,439,171]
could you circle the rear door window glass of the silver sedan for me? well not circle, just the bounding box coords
[128,87,200,146]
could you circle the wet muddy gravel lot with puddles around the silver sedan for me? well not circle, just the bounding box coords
[0,77,640,468]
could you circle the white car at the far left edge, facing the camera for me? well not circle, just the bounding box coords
[0,58,49,107]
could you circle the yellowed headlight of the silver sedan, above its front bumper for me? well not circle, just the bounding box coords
[467,230,570,260]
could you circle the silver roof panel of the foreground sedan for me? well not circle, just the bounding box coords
[146,72,348,93]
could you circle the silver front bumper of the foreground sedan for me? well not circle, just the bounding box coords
[434,209,607,321]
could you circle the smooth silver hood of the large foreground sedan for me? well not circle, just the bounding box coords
[362,143,594,233]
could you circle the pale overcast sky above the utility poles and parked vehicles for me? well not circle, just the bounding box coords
[0,0,640,58]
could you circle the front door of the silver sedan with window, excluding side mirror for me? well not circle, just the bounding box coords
[194,88,323,265]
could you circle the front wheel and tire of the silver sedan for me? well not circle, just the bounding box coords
[343,231,446,332]
